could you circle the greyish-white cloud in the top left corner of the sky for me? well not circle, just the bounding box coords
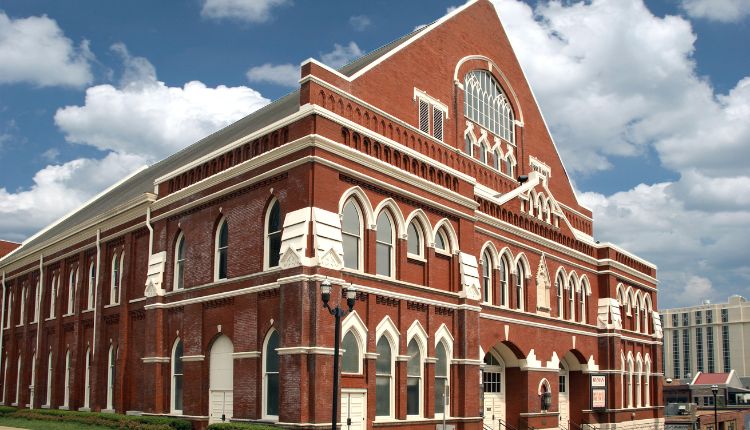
[0,11,93,87]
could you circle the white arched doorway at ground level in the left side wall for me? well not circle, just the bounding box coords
[208,335,234,424]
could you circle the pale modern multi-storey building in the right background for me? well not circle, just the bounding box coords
[662,296,750,380]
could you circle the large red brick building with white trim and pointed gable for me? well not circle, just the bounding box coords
[0,0,663,429]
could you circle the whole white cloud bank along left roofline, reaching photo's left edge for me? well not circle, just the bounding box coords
[0,44,268,244]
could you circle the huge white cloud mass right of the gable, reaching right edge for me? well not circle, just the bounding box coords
[494,0,750,306]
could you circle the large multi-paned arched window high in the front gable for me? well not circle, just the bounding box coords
[464,70,515,143]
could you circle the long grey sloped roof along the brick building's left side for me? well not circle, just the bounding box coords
[0,90,299,261]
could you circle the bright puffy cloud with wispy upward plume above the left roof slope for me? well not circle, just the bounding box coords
[55,45,269,161]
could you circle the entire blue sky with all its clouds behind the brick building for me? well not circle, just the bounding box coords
[0,0,750,307]
